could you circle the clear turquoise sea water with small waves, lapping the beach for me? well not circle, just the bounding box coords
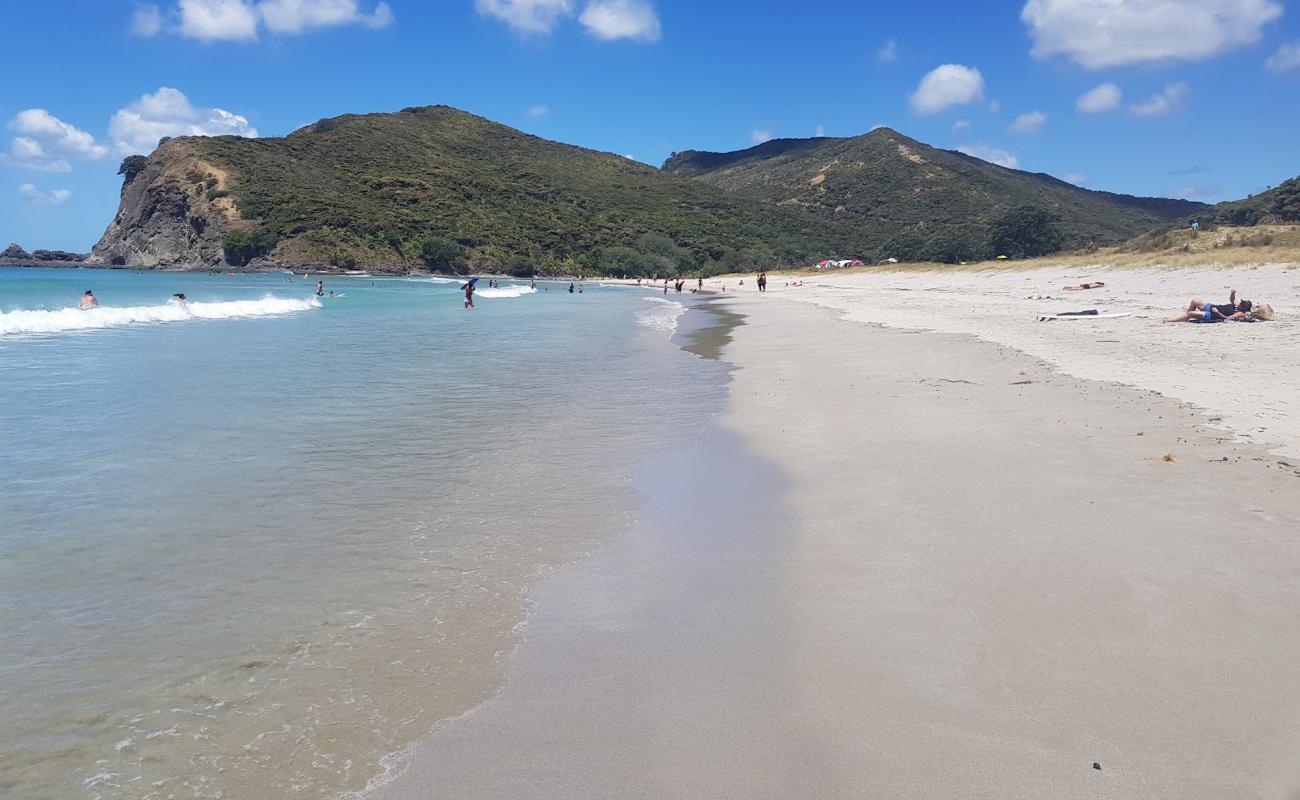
[0,269,725,800]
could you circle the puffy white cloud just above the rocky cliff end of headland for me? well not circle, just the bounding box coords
[108,86,257,155]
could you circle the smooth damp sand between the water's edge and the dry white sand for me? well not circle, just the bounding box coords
[361,295,1300,800]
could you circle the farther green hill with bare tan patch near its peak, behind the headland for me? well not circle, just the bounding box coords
[663,127,1205,261]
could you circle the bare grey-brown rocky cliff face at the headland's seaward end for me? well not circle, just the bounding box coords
[90,139,250,268]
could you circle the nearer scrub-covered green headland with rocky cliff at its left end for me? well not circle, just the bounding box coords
[95,107,871,274]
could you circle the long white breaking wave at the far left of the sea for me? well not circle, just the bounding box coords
[0,297,321,336]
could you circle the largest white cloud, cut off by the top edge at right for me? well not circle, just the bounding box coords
[1021,0,1282,69]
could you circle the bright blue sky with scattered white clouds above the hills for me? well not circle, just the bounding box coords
[0,0,1300,251]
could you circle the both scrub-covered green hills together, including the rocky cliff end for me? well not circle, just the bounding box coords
[91,105,1203,276]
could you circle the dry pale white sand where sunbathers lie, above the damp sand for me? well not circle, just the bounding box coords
[707,265,1300,458]
